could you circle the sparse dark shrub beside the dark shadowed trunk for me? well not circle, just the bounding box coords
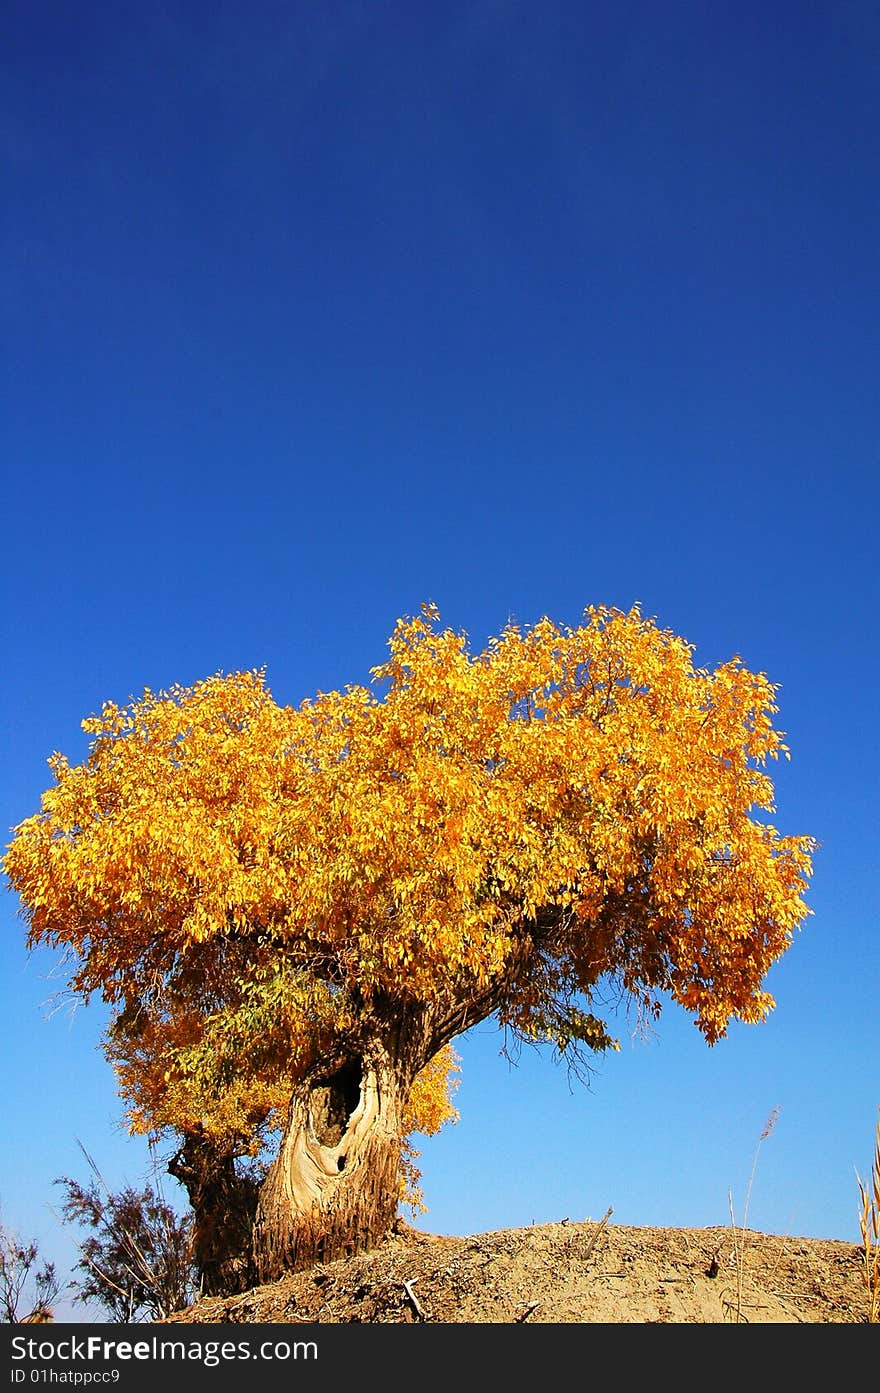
[57,1149,198,1325]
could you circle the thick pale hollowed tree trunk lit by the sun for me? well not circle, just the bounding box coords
[253,1031,414,1282]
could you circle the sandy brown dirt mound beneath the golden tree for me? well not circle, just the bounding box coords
[160,1216,867,1325]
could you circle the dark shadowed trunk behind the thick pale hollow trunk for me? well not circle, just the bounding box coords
[168,1134,259,1295]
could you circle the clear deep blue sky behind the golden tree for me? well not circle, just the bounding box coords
[0,0,880,1320]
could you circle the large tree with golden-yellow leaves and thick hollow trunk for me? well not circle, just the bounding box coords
[4,606,815,1280]
